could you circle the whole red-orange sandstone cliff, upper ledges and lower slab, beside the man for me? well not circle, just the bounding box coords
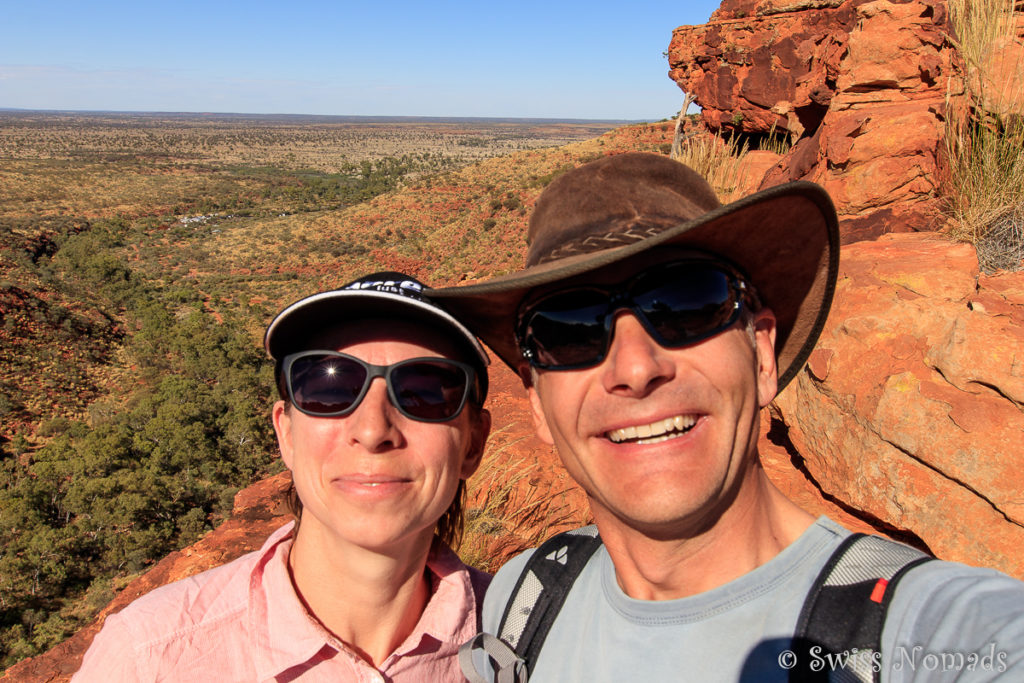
[669,0,1024,593]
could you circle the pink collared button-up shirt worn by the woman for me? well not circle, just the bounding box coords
[72,524,490,683]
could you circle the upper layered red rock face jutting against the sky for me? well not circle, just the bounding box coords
[669,0,962,243]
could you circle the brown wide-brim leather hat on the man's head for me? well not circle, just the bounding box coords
[427,153,840,390]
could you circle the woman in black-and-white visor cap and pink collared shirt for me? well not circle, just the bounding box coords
[74,272,490,683]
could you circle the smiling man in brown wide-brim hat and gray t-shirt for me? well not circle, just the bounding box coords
[432,154,1024,681]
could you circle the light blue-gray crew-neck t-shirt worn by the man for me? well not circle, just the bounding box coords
[483,517,1024,683]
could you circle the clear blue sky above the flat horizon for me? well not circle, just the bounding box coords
[0,0,719,120]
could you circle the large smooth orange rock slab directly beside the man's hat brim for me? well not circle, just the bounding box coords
[773,233,1024,578]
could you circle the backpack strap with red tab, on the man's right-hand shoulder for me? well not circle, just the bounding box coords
[790,533,932,683]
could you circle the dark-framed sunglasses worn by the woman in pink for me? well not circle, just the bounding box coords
[282,350,474,422]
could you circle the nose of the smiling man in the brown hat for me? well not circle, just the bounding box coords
[602,311,676,396]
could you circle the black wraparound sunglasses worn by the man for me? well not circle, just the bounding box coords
[516,259,760,370]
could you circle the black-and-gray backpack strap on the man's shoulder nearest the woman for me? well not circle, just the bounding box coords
[460,525,601,683]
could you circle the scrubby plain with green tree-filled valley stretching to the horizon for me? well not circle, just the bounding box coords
[0,111,673,667]
